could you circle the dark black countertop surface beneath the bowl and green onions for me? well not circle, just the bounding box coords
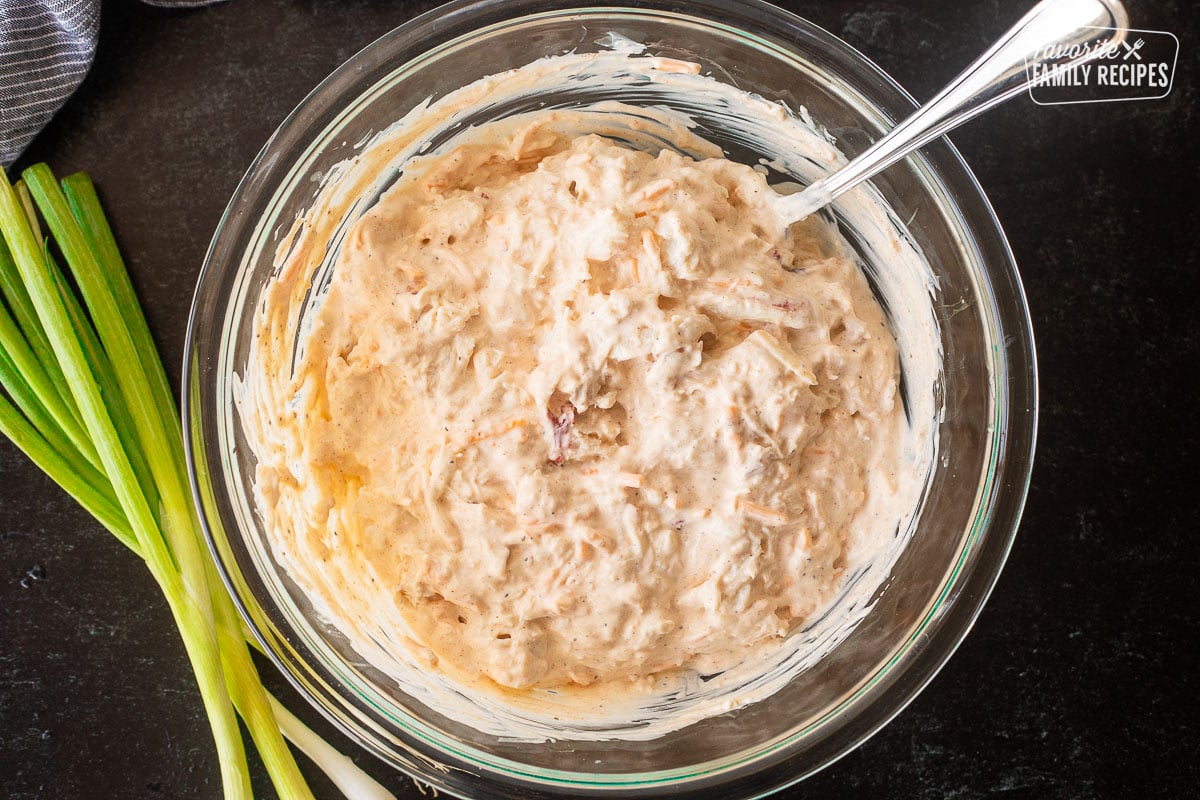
[0,0,1200,800]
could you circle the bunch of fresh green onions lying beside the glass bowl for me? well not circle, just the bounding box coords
[0,164,391,800]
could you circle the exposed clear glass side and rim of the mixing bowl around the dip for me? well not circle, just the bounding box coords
[184,0,1037,798]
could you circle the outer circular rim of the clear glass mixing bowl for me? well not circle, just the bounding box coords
[182,0,1038,794]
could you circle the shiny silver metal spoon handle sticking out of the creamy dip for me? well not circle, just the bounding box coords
[779,0,1129,219]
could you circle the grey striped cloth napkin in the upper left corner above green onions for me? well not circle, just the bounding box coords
[0,0,217,167]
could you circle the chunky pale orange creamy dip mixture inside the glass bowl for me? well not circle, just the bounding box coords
[242,48,931,738]
